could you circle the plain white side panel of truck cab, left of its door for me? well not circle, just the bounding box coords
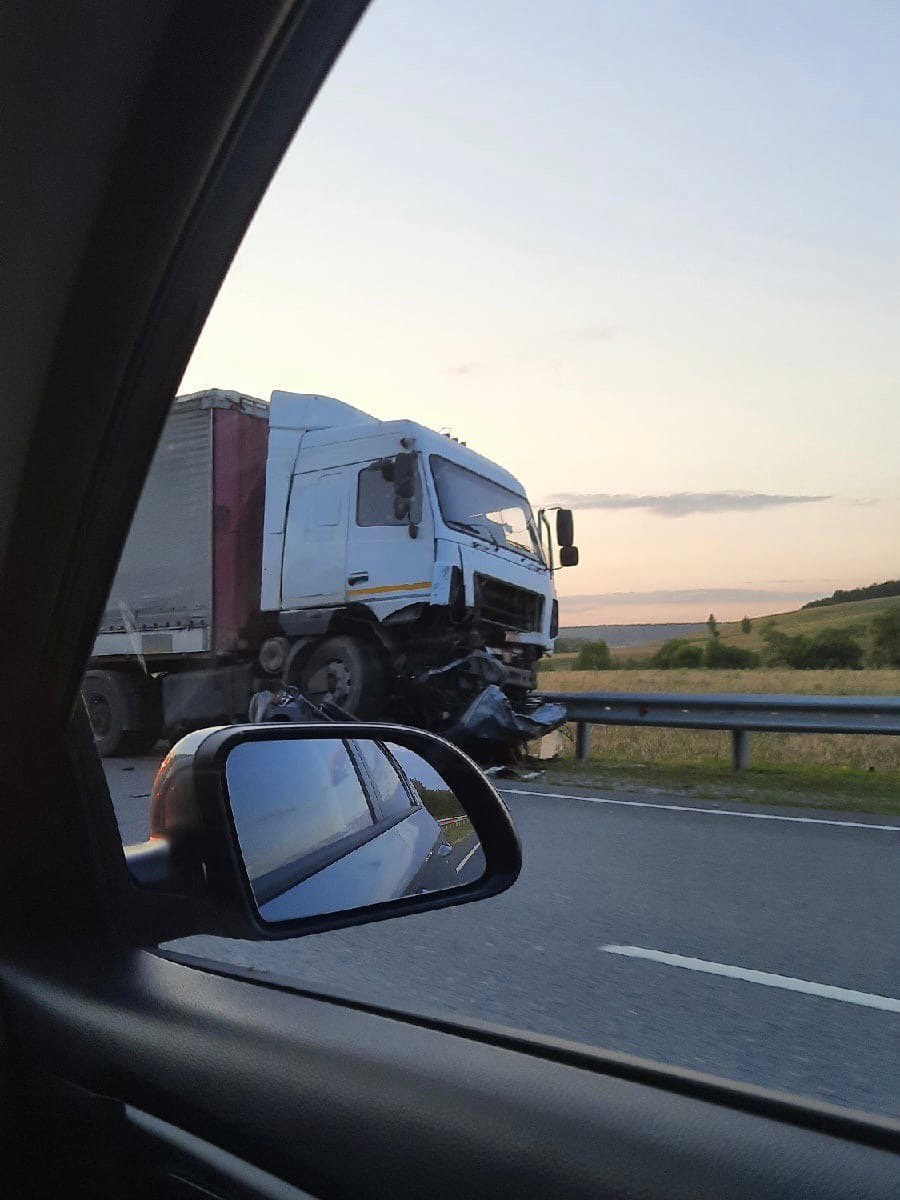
[281,467,350,608]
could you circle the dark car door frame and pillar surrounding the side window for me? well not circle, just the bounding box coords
[0,0,899,1198]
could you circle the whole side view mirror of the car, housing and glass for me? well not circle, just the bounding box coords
[126,722,521,940]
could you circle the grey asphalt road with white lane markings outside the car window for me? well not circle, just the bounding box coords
[107,760,900,1115]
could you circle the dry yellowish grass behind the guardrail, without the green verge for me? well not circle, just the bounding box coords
[541,668,900,772]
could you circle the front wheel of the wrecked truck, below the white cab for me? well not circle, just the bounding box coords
[298,637,388,718]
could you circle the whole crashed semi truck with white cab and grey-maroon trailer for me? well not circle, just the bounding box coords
[83,389,577,755]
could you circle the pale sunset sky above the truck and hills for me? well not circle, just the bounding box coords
[181,0,900,625]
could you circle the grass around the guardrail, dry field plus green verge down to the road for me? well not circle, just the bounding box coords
[532,667,900,811]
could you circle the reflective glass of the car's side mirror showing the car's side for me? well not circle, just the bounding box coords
[226,738,485,922]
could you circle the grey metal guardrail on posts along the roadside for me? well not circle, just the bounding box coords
[540,691,900,770]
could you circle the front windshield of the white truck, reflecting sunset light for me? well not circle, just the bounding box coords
[431,455,542,559]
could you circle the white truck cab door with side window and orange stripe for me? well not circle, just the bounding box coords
[347,462,434,619]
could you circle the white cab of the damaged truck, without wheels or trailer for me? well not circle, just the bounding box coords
[262,391,564,664]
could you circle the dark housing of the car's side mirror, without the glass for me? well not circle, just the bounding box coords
[126,722,522,941]
